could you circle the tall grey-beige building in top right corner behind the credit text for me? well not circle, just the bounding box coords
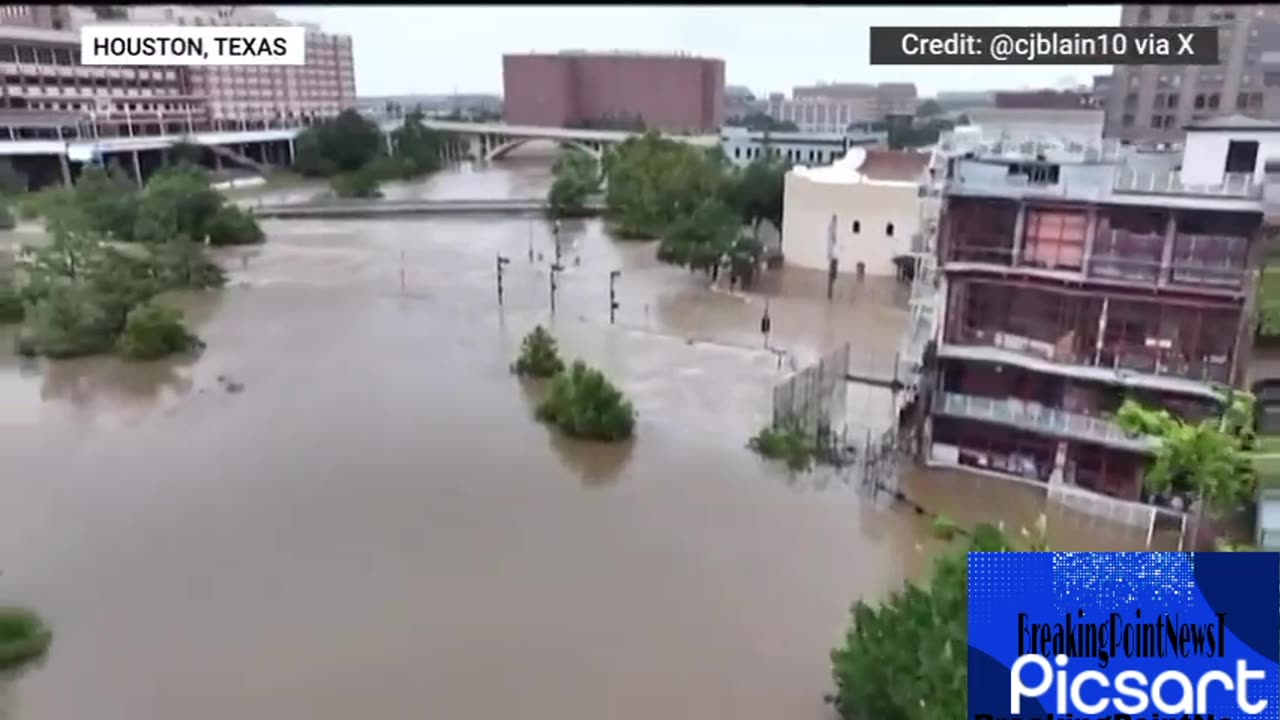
[1105,4,1280,143]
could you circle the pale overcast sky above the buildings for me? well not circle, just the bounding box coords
[279,5,1120,96]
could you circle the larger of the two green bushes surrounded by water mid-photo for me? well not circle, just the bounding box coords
[538,360,635,442]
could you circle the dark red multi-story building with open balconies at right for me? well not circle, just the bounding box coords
[925,120,1280,500]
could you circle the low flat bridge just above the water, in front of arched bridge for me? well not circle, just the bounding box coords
[248,197,604,219]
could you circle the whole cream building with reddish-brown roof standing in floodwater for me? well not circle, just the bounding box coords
[782,147,931,277]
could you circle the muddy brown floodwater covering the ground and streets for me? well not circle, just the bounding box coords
[0,144,1162,720]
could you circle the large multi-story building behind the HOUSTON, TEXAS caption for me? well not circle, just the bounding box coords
[0,5,356,138]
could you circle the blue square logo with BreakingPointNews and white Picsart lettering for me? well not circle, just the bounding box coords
[969,552,1280,720]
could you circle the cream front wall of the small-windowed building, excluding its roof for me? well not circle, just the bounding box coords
[782,173,920,277]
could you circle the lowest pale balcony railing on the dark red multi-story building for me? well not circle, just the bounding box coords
[938,392,1156,452]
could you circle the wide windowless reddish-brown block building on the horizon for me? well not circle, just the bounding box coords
[502,51,724,135]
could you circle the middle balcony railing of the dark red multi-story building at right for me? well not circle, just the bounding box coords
[946,327,1231,383]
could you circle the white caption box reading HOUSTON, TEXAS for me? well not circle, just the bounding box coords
[81,24,307,65]
